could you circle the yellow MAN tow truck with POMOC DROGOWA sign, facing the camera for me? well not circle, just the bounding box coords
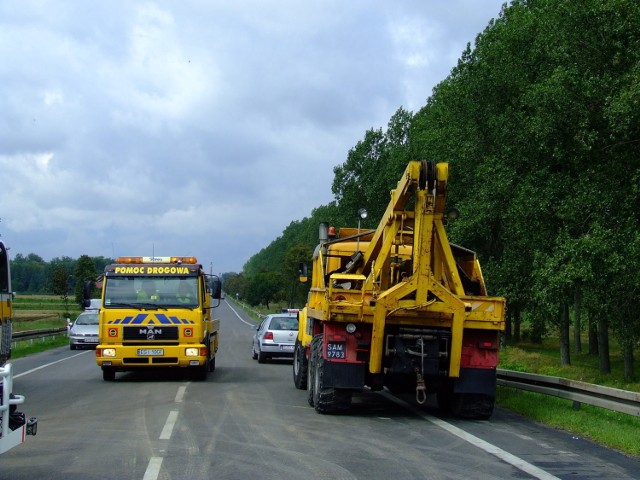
[84,256,221,381]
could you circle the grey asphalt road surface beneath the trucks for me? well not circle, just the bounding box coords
[0,302,640,480]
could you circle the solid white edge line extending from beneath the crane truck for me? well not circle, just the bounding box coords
[380,392,559,480]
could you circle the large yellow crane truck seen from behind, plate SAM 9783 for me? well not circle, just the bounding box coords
[293,161,506,418]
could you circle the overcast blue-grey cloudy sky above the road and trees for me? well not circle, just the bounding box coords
[0,0,503,273]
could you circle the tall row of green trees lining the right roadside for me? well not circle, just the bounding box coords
[225,0,640,378]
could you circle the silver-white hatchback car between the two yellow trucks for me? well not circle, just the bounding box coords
[251,312,298,363]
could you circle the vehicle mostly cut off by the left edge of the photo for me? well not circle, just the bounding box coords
[0,242,38,453]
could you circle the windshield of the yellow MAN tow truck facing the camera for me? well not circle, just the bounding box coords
[104,276,198,308]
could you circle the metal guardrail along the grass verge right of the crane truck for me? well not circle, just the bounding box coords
[497,370,640,417]
